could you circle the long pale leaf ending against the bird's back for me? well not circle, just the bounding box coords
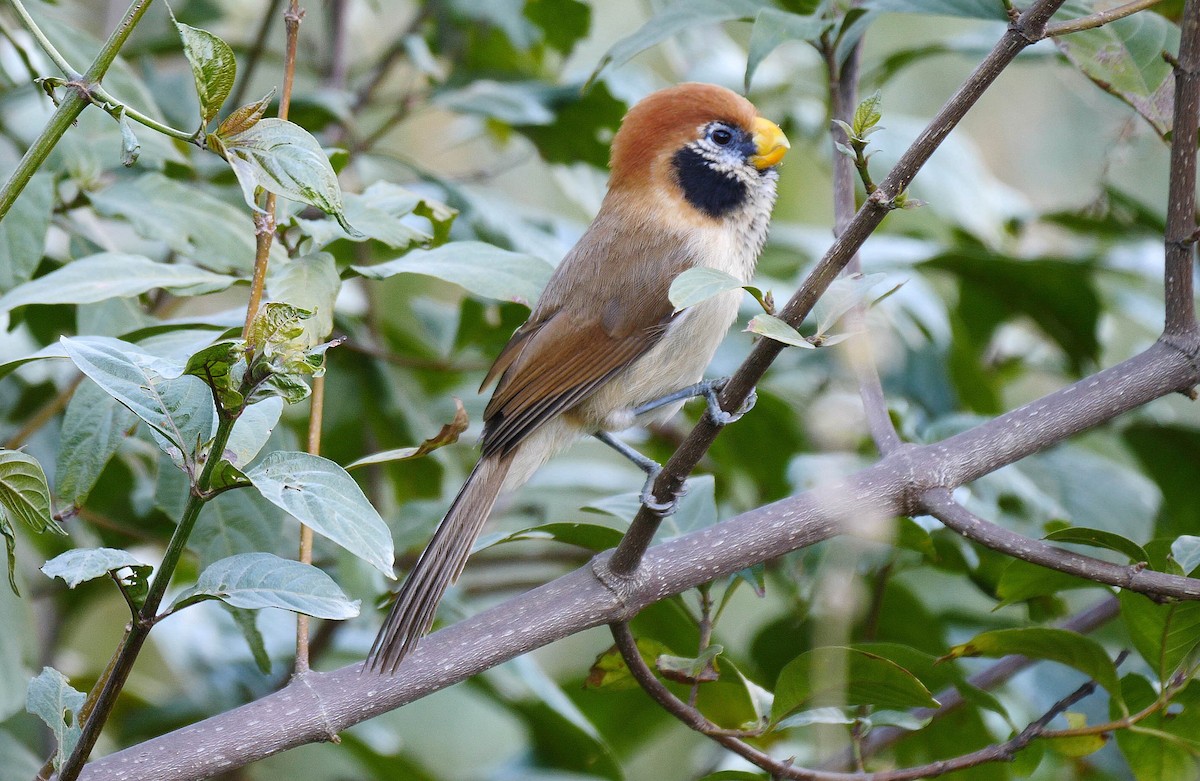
[350,241,552,306]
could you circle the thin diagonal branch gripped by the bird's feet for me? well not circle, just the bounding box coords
[611,0,1064,577]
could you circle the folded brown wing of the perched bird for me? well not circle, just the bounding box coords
[472,229,694,455]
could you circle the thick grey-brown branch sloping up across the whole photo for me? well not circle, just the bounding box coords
[82,332,1200,781]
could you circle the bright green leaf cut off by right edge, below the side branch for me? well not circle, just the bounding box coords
[1117,591,1200,681]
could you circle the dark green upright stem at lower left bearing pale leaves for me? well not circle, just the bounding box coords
[58,416,236,781]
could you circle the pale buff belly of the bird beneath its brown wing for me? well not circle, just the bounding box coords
[572,290,742,431]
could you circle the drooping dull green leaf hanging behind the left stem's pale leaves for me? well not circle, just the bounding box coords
[54,380,138,506]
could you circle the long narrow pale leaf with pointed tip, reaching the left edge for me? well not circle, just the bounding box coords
[0,252,238,311]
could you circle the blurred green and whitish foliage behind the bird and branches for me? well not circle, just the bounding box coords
[0,0,1200,781]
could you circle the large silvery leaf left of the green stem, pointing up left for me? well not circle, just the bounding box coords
[60,336,215,464]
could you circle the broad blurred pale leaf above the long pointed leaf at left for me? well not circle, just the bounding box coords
[88,173,274,276]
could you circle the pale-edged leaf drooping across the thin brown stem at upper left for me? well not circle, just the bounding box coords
[210,118,358,234]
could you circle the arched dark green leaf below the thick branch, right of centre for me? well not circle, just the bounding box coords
[770,645,937,723]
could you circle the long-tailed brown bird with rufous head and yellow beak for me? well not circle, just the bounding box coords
[364,83,790,674]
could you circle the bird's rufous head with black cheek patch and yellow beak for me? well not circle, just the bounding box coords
[608,83,788,220]
